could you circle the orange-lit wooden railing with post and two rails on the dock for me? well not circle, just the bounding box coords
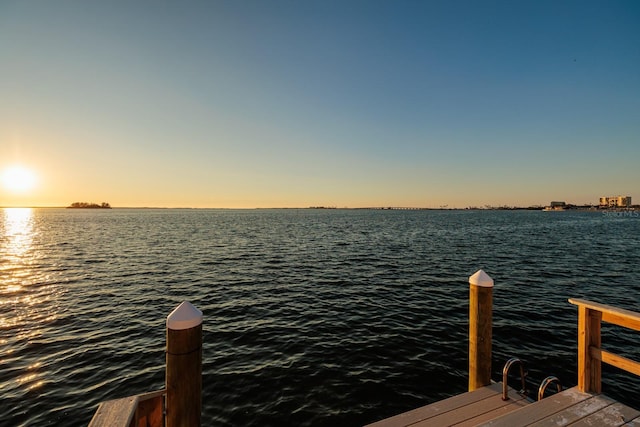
[569,298,640,393]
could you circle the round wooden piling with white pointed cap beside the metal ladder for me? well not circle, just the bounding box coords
[469,270,493,391]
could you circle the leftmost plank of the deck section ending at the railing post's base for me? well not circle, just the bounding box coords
[482,387,592,427]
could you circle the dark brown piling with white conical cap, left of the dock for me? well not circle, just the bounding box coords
[166,301,202,427]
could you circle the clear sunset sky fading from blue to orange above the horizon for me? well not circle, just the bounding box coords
[0,0,640,208]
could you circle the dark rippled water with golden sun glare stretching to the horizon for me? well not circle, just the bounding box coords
[0,209,640,427]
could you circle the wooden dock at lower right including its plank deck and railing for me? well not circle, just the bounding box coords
[369,299,640,427]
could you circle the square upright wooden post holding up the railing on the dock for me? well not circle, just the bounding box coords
[578,305,602,393]
